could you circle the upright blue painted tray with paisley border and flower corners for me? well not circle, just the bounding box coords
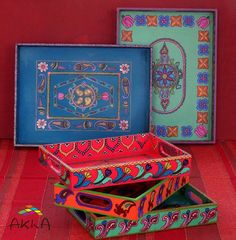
[15,44,151,145]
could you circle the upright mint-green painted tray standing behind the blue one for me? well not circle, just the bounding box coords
[117,9,217,143]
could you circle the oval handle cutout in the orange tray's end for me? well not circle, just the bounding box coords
[76,192,112,211]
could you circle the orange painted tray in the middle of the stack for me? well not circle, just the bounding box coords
[54,176,189,220]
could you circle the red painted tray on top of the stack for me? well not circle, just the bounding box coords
[39,133,191,191]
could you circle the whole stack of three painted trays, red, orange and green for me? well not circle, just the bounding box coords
[39,133,217,238]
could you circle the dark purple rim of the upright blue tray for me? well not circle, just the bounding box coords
[13,42,152,147]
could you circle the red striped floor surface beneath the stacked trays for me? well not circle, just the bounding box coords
[0,140,236,240]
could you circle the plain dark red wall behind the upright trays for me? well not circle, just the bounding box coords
[0,0,236,139]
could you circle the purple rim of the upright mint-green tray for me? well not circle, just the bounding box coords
[116,7,218,144]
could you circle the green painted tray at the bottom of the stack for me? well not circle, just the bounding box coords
[69,184,217,239]
